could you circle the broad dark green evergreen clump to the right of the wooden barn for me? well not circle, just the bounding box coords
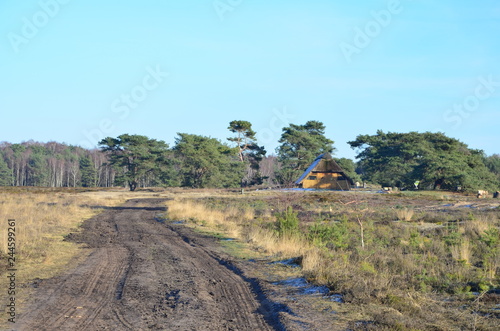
[349,131,498,190]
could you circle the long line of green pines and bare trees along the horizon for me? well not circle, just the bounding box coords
[0,120,500,191]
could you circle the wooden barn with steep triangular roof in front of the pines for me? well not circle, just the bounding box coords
[295,153,354,191]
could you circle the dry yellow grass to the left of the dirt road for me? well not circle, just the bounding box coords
[0,191,125,322]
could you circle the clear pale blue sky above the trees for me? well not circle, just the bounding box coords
[0,0,500,158]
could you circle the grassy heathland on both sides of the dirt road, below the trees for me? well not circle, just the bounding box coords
[0,187,500,330]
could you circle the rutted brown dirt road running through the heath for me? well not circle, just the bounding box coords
[16,199,285,330]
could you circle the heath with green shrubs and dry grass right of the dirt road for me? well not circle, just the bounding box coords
[167,192,500,330]
